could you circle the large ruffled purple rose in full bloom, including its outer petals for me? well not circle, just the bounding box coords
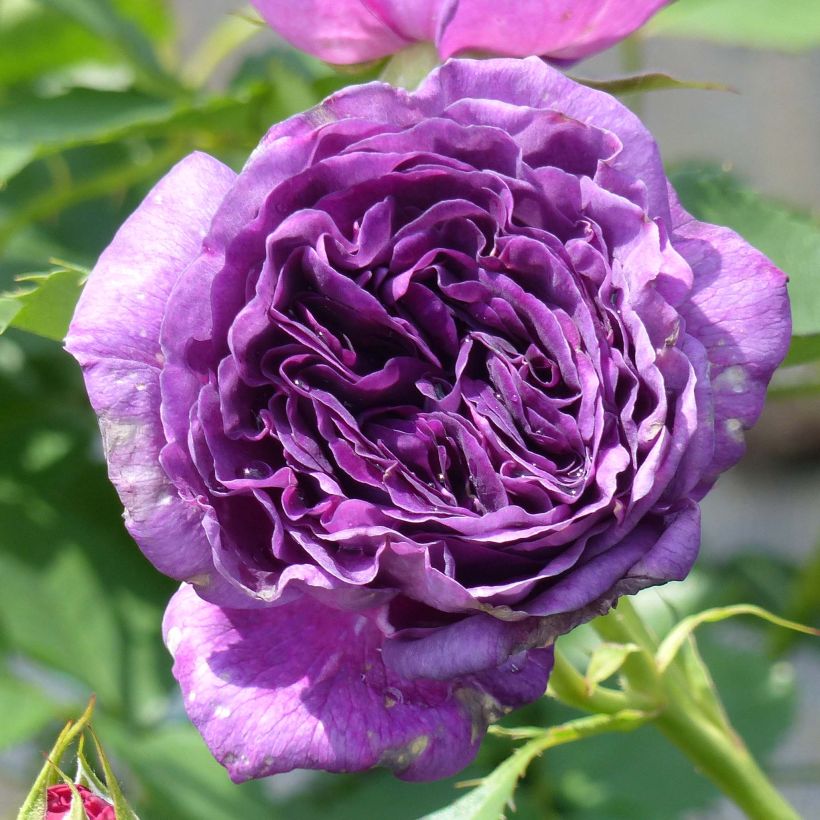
[67,58,790,780]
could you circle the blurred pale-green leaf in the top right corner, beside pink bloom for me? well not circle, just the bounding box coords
[643,0,820,51]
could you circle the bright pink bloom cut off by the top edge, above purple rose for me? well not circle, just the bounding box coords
[252,0,671,64]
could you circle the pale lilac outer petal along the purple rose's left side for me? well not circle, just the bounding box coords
[66,153,235,579]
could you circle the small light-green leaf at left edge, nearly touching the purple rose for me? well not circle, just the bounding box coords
[0,267,88,341]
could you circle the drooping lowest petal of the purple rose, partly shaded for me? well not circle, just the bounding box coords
[163,586,552,781]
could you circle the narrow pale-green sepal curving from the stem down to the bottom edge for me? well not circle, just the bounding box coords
[422,709,652,820]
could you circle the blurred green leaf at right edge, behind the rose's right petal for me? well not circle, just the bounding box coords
[671,165,820,364]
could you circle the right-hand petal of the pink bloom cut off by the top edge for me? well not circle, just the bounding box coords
[437,0,669,60]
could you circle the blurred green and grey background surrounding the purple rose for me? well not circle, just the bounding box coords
[0,0,820,820]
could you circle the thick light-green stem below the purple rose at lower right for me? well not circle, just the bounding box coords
[550,598,799,820]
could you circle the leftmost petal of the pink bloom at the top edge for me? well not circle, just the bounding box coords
[247,0,410,64]
